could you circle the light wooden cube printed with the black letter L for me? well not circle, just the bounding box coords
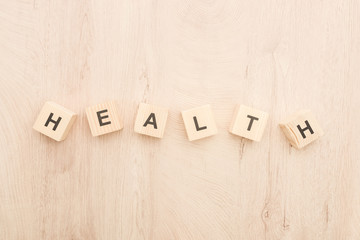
[182,105,217,141]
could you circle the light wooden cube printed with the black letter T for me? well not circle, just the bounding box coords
[229,105,269,142]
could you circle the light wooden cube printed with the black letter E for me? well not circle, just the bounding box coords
[86,101,123,137]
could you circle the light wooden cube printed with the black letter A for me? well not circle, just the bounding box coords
[134,103,168,138]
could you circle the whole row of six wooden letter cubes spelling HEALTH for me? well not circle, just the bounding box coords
[33,101,323,149]
